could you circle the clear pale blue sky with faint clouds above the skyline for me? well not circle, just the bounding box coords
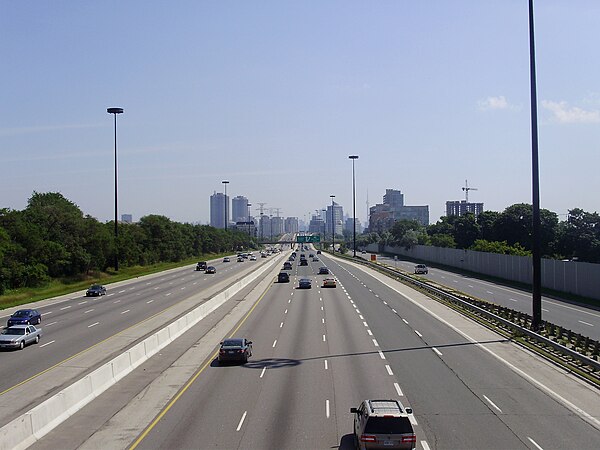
[0,0,600,223]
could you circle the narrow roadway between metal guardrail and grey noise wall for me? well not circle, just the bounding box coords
[361,253,600,340]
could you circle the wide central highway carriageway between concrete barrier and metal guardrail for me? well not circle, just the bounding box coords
[33,248,600,450]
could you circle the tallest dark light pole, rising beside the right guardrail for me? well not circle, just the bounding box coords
[529,0,542,331]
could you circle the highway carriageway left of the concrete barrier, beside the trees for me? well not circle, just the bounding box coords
[0,257,276,425]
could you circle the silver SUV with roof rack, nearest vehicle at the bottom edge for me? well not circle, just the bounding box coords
[350,400,417,450]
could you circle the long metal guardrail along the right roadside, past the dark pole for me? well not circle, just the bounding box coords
[342,256,600,385]
